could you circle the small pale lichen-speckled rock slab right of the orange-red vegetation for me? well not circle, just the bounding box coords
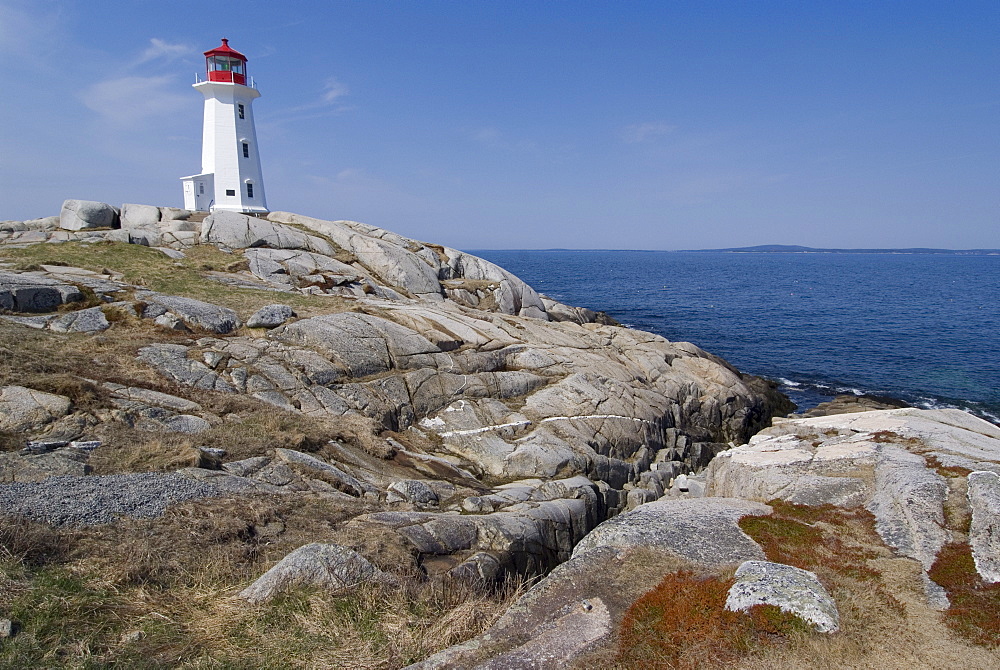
[726,561,840,633]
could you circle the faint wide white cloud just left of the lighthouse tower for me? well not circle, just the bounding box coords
[80,77,191,125]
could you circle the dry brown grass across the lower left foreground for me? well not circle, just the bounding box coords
[0,494,519,668]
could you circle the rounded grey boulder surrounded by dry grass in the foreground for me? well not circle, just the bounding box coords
[240,542,391,604]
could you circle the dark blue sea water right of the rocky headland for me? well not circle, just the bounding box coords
[472,251,1000,422]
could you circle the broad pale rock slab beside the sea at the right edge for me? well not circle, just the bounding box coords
[706,408,1000,600]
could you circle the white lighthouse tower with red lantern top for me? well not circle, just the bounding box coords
[181,39,268,214]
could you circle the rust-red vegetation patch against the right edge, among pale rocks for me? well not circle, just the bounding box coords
[928,542,1000,647]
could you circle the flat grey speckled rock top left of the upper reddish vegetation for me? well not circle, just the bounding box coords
[573,498,771,566]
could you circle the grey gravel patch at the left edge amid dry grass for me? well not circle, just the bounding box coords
[0,472,226,526]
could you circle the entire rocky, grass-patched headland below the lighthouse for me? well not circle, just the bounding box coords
[0,201,1000,668]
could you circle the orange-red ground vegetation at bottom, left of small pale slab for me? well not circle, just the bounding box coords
[617,570,810,668]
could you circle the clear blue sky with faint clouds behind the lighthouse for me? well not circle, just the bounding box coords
[0,0,1000,249]
